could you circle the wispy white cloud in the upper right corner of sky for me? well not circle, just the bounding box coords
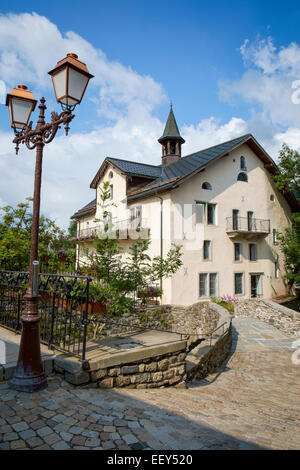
[220,38,300,127]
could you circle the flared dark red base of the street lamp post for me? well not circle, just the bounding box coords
[8,314,47,393]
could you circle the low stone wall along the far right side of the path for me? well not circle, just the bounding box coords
[234,299,300,336]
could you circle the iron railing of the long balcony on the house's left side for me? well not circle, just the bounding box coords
[77,219,147,238]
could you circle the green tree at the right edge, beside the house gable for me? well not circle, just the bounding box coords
[274,143,300,286]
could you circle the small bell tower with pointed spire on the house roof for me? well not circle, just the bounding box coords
[158,105,185,167]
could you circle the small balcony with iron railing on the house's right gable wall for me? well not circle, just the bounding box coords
[226,217,270,238]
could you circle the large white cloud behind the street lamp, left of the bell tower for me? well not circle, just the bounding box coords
[0,13,166,226]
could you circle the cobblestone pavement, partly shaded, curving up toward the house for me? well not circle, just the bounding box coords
[0,318,300,450]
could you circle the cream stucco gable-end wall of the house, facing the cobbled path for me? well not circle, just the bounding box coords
[171,145,291,305]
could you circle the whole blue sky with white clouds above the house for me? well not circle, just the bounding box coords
[0,0,300,225]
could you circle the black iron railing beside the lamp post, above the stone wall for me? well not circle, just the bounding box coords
[0,270,190,364]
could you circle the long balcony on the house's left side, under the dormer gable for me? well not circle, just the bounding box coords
[71,219,149,241]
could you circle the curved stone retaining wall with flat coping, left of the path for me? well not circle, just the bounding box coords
[54,302,231,388]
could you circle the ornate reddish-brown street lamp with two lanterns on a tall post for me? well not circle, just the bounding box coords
[6,54,93,392]
